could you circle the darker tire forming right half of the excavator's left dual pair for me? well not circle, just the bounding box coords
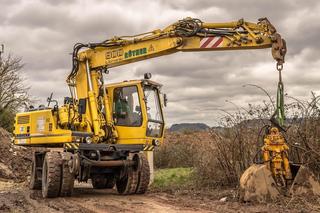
[60,153,74,197]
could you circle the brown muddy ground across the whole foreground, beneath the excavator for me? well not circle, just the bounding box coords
[0,181,320,213]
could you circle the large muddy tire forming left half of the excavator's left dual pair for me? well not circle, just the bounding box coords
[42,152,62,198]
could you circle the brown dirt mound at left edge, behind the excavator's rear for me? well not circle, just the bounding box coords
[0,128,32,182]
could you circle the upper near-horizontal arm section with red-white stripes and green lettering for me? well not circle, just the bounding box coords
[68,18,286,75]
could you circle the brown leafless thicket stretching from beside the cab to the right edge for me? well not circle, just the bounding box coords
[156,91,320,186]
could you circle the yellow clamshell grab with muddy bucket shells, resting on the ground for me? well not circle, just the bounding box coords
[240,127,320,202]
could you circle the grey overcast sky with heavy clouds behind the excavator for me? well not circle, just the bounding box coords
[0,0,320,125]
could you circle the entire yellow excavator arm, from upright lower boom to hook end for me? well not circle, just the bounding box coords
[67,18,286,141]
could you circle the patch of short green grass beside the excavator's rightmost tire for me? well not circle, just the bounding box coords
[152,168,193,191]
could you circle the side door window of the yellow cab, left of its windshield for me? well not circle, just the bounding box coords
[113,86,142,126]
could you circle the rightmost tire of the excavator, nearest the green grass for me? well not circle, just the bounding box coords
[135,153,150,194]
